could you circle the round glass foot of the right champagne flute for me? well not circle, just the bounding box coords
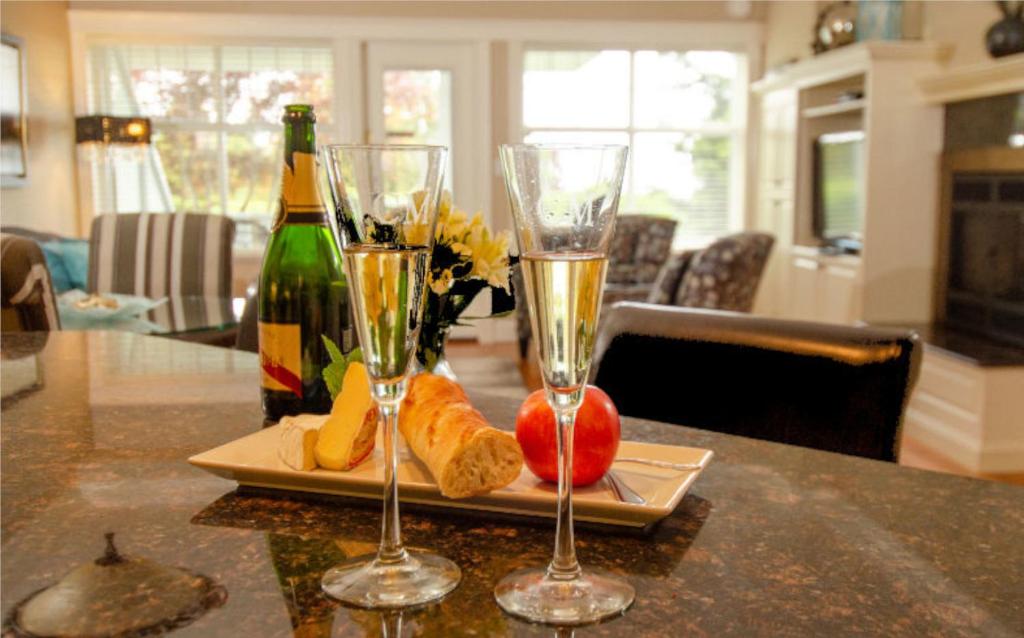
[495,567,636,625]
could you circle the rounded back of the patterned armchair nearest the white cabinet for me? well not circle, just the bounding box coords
[674,232,775,312]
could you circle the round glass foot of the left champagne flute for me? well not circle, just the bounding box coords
[321,552,462,609]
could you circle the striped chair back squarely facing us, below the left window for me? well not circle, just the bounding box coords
[88,213,234,299]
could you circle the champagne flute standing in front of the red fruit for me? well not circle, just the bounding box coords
[495,144,635,625]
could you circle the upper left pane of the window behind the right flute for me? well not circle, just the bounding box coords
[522,51,630,128]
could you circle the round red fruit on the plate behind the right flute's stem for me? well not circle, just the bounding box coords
[515,385,620,486]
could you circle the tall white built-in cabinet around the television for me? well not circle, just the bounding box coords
[752,42,948,324]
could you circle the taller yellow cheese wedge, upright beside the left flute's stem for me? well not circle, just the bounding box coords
[313,361,377,470]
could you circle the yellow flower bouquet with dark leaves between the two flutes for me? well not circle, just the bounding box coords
[416,190,515,376]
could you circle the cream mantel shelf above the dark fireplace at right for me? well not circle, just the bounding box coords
[918,53,1024,104]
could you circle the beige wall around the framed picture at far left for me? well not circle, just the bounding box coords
[0,2,80,236]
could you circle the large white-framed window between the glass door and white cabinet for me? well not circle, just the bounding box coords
[522,48,746,247]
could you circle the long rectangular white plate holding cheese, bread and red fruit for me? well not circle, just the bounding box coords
[188,425,713,527]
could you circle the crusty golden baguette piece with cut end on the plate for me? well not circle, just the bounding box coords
[398,374,522,499]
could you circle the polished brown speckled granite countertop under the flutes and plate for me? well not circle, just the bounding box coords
[6,332,1024,638]
